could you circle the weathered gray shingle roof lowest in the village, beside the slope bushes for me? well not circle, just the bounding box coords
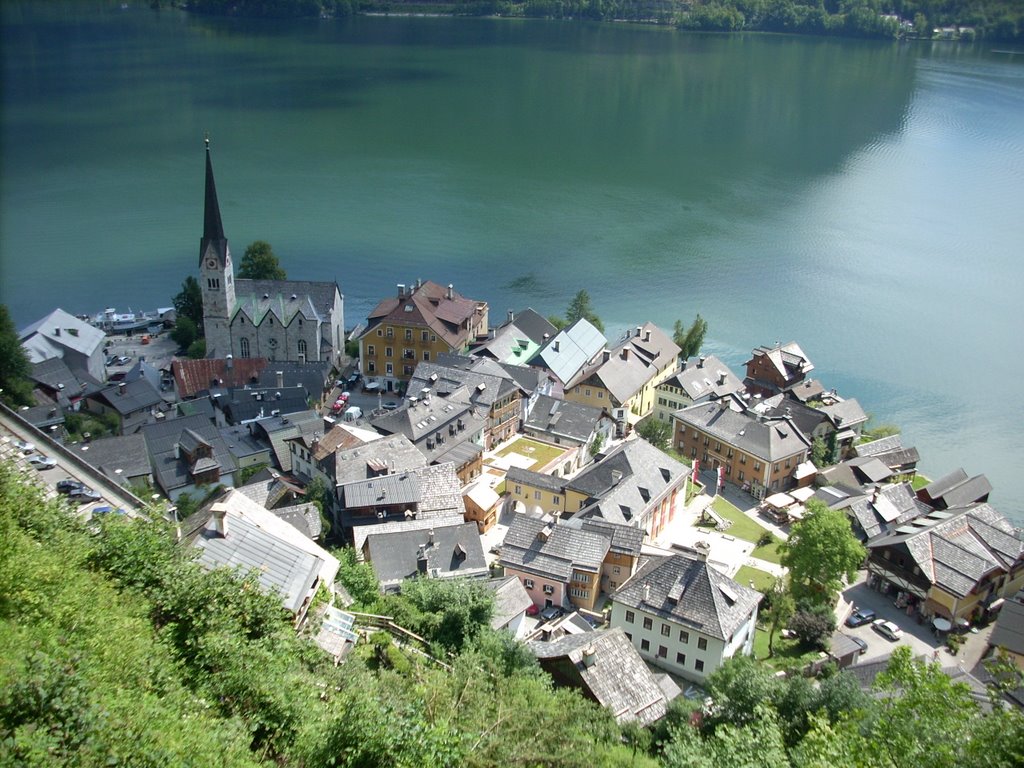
[528,627,668,725]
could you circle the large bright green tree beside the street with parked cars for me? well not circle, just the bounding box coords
[779,499,867,606]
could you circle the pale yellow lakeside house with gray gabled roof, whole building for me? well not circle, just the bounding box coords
[565,323,679,424]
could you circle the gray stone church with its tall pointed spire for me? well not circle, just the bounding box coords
[199,139,345,366]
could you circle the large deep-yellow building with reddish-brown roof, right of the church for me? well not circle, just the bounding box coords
[359,281,487,391]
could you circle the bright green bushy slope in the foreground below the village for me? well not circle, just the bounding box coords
[0,465,1024,768]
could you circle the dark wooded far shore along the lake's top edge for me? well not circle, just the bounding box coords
[183,0,1024,41]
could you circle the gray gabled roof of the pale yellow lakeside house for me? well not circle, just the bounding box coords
[567,323,679,403]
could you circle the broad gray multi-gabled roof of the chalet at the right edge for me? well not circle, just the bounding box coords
[867,504,1024,597]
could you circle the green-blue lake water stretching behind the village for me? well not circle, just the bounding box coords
[0,2,1024,522]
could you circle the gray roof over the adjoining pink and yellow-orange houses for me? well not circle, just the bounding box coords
[500,514,610,582]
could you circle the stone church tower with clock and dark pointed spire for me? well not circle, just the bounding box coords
[199,138,234,357]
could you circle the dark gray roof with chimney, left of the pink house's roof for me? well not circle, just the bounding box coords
[366,522,488,586]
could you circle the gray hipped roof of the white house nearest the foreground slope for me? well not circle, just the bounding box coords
[611,554,762,640]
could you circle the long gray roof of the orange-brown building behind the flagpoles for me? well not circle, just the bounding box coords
[673,403,811,463]
